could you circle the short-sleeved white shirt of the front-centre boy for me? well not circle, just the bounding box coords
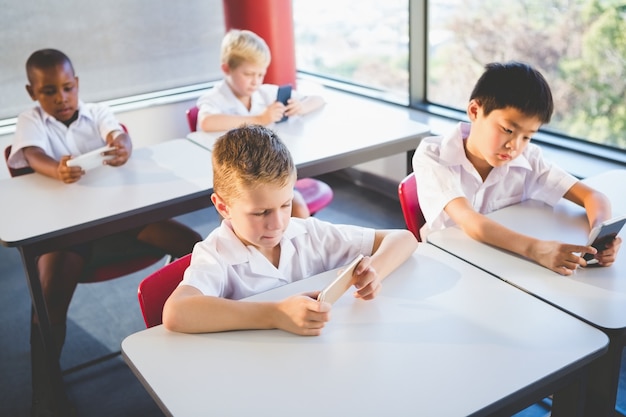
[181,217,375,300]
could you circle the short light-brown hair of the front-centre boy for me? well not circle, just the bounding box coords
[212,125,296,203]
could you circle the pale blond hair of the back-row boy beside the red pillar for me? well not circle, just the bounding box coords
[222,29,271,69]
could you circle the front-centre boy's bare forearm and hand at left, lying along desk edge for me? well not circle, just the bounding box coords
[163,285,330,336]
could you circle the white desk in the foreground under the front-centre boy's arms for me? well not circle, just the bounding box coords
[122,244,608,417]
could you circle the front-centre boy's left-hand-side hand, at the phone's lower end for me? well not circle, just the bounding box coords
[275,293,331,336]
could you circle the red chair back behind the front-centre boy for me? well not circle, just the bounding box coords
[137,254,191,327]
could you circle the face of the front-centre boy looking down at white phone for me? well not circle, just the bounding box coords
[212,178,295,254]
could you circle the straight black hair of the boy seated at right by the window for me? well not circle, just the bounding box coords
[470,61,554,124]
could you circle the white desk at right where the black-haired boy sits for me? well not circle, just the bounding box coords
[428,170,626,417]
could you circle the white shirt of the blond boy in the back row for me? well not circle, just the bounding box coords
[196,80,301,130]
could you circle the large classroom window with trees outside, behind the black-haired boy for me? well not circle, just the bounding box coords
[293,0,626,151]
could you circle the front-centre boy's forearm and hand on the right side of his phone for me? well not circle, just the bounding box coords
[354,229,418,300]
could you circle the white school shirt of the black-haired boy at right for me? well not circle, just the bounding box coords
[413,122,578,239]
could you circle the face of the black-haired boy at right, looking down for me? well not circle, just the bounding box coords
[465,100,541,171]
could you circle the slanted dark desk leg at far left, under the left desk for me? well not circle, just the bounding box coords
[20,247,70,416]
